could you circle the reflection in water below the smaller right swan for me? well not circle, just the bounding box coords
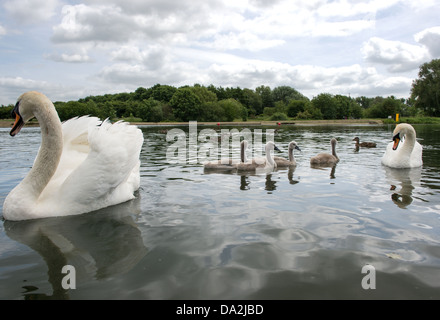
[383,166,422,209]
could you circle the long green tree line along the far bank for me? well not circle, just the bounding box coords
[0,59,440,122]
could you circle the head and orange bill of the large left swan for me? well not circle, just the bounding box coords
[9,91,52,136]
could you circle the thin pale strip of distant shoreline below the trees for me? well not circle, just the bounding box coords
[0,119,383,128]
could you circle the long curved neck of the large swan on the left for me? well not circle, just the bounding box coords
[20,105,63,199]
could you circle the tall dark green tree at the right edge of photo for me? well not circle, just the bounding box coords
[411,59,440,117]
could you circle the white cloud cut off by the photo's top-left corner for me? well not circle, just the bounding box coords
[3,0,59,24]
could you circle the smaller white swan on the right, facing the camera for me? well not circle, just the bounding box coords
[382,123,423,168]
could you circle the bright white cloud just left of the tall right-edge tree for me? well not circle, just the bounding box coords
[362,37,429,72]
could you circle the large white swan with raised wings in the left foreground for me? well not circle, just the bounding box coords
[3,91,143,220]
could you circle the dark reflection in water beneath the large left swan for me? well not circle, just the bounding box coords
[4,197,148,299]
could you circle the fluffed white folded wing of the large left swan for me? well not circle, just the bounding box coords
[60,121,143,212]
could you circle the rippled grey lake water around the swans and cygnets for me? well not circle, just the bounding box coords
[0,125,440,299]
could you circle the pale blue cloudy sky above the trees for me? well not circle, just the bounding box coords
[0,0,440,104]
